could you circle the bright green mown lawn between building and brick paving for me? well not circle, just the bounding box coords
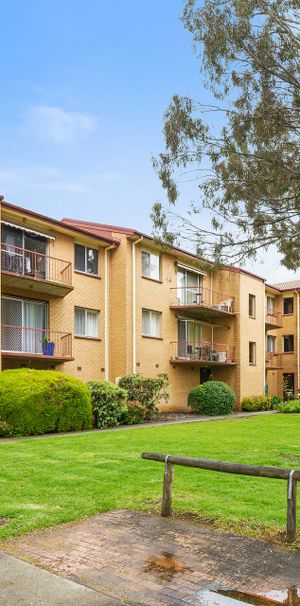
[0,414,300,539]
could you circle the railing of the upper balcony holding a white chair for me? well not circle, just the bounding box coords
[171,286,234,313]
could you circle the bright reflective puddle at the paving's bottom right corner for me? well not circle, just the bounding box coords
[197,587,300,606]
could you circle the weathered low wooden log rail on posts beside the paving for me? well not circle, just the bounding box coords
[141,452,300,543]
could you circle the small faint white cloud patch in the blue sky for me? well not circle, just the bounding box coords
[24,105,97,144]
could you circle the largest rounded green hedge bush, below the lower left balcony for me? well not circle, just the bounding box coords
[0,368,92,436]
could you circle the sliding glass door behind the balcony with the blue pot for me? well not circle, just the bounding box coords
[1,297,48,354]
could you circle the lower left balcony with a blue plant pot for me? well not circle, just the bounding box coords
[1,324,74,364]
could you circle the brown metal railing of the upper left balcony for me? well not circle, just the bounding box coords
[1,243,72,287]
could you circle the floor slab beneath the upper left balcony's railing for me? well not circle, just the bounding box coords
[1,271,73,297]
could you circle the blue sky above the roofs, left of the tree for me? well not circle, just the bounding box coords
[0,0,294,281]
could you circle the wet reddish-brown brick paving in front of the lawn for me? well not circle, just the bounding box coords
[0,510,300,606]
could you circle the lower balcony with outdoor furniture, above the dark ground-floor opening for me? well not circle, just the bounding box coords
[170,341,236,366]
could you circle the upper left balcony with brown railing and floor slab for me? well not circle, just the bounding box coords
[1,243,73,297]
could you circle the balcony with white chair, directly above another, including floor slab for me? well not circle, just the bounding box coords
[170,286,236,319]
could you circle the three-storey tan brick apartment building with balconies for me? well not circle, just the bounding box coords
[0,198,300,410]
